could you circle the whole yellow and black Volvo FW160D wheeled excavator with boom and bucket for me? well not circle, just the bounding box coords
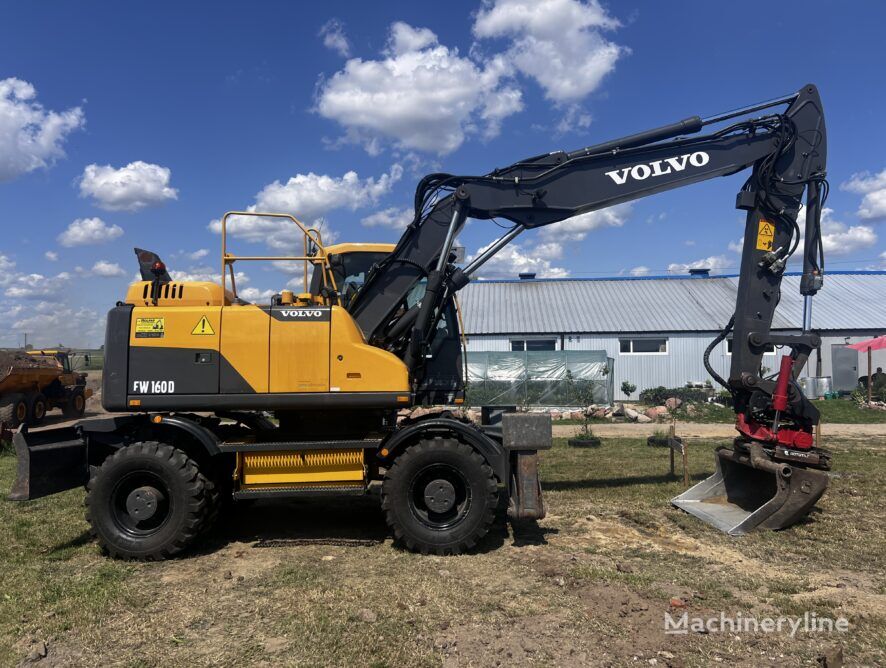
[11,85,830,559]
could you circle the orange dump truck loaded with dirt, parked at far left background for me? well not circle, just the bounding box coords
[0,350,92,429]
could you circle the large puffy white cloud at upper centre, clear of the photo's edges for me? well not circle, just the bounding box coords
[316,21,523,155]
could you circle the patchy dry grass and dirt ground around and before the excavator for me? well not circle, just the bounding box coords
[0,428,886,667]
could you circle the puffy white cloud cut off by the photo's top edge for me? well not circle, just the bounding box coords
[473,0,630,105]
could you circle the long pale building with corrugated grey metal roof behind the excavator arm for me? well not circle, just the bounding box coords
[459,271,886,399]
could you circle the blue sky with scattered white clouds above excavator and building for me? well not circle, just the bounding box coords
[0,0,886,346]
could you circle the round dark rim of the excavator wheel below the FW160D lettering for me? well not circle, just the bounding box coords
[111,471,172,538]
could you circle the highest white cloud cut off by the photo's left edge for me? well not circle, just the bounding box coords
[0,78,86,183]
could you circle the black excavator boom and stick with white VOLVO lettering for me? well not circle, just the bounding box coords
[350,85,827,422]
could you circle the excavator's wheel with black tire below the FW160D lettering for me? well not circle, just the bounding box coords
[86,441,210,561]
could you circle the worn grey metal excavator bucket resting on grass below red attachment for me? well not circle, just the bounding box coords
[671,448,828,536]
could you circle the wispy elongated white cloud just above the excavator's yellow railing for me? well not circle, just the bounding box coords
[209,165,403,255]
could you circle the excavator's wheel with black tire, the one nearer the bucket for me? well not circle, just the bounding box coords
[381,438,498,555]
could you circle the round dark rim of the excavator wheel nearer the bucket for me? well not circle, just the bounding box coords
[409,463,471,530]
